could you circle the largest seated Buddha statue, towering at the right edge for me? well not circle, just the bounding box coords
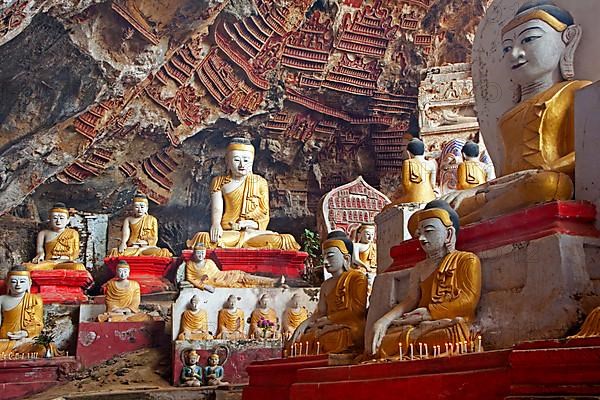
[444,1,590,225]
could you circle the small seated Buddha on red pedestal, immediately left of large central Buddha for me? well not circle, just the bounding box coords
[110,193,173,257]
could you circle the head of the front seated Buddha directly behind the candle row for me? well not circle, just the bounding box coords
[408,200,460,258]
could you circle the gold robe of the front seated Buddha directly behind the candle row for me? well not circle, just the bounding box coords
[379,251,481,358]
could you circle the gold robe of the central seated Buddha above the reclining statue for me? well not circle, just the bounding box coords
[187,174,300,250]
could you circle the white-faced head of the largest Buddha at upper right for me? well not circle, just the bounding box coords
[502,0,582,101]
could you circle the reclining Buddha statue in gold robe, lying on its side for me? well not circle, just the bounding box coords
[185,243,285,293]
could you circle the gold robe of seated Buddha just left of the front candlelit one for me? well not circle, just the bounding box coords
[297,270,367,354]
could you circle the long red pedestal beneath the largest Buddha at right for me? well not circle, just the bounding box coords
[385,201,600,272]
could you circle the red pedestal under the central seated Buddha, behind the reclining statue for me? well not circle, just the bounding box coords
[181,249,308,278]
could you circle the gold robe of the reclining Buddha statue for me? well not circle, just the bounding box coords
[185,260,275,290]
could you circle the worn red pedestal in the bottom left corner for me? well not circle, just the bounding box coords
[0,356,78,400]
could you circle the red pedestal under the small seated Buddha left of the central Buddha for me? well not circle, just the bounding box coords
[104,256,176,294]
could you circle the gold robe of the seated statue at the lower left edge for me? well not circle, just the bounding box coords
[0,293,44,356]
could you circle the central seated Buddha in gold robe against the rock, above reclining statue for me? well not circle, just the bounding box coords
[187,138,300,250]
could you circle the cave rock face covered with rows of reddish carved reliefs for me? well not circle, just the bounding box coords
[0,0,486,262]
